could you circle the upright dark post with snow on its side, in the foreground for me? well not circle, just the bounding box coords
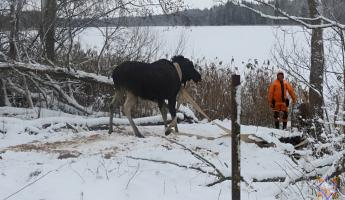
[231,75,241,200]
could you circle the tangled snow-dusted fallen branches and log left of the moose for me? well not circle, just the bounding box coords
[0,62,113,115]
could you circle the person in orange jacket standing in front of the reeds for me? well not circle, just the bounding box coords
[268,71,296,129]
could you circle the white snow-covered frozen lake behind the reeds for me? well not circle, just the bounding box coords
[80,26,342,99]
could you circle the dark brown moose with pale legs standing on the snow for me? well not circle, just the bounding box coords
[109,55,201,137]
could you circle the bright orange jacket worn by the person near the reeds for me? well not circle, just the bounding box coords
[268,79,296,112]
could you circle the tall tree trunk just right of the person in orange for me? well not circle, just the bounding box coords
[308,0,324,138]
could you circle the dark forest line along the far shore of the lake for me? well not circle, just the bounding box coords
[0,0,320,29]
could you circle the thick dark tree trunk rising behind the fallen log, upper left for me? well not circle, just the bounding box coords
[41,0,57,62]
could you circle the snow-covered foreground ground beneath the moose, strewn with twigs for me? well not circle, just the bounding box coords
[0,107,322,200]
